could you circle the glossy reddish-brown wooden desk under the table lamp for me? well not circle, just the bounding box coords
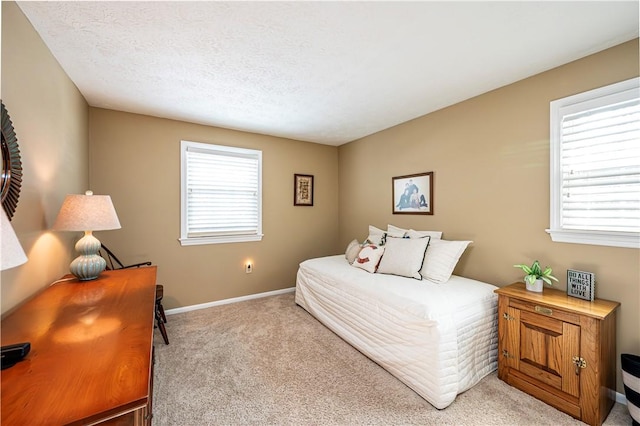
[0,266,156,425]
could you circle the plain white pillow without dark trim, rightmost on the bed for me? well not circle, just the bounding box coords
[420,238,473,284]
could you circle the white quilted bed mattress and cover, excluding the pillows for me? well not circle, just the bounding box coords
[295,255,498,409]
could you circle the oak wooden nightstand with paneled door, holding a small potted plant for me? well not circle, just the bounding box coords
[495,283,620,425]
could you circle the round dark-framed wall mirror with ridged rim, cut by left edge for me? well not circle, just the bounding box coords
[0,103,22,220]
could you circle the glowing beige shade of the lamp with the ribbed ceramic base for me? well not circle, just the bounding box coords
[53,191,121,231]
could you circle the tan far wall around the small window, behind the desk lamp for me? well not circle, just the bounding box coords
[90,108,339,308]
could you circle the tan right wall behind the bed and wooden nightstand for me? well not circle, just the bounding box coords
[339,39,640,391]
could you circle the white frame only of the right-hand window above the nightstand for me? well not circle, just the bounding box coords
[546,77,640,248]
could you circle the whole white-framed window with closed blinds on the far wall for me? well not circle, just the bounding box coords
[180,141,262,246]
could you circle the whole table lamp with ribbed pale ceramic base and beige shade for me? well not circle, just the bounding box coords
[53,191,121,281]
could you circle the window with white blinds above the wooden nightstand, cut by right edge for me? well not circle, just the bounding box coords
[547,78,640,248]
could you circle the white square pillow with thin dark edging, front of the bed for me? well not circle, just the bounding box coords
[377,237,430,280]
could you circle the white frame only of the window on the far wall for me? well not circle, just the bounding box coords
[178,140,264,246]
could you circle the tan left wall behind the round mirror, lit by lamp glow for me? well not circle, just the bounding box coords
[1,1,89,313]
